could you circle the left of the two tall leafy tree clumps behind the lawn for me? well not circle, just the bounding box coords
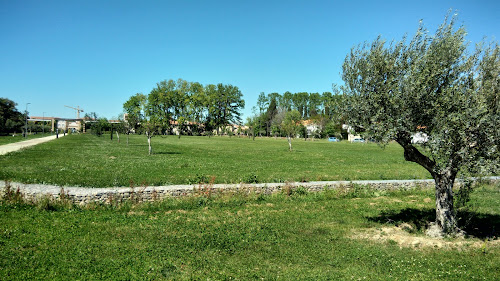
[123,79,245,153]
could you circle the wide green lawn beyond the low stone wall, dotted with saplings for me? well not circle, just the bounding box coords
[0,134,430,187]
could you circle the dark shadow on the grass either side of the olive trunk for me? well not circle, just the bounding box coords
[367,208,500,239]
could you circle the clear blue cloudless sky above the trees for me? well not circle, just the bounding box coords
[0,0,500,118]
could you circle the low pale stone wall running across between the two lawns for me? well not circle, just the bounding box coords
[0,177,500,204]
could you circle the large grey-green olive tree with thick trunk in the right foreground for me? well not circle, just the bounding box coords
[342,16,500,236]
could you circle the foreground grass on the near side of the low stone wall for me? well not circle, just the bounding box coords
[0,183,500,280]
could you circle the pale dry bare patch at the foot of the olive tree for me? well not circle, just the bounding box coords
[351,223,500,250]
